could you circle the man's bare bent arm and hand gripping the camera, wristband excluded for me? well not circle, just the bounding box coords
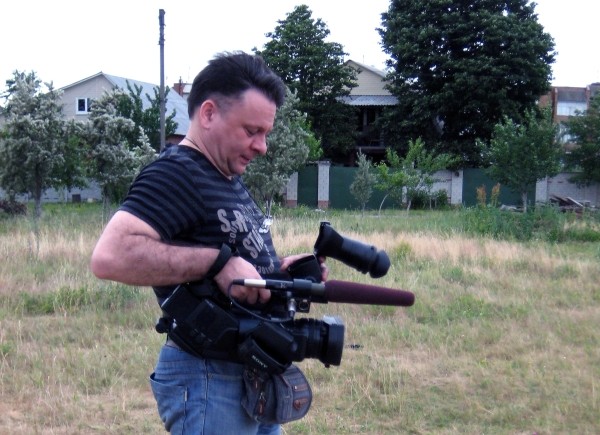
[90,211,270,303]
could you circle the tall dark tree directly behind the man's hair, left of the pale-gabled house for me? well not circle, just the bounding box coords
[254,5,356,160]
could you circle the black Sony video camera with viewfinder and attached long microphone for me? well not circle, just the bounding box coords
[156,222,414,373]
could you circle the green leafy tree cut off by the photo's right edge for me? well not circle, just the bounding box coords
[566,92,600,185]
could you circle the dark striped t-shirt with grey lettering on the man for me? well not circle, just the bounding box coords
[121,145,280,300]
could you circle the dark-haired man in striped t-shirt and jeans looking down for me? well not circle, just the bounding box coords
[91,53,326,435]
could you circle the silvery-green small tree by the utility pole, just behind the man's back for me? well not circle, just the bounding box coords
[84,89,155,211]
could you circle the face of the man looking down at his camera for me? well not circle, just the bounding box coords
[206,89,277,177]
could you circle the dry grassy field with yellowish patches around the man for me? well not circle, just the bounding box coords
[0,204,600,434]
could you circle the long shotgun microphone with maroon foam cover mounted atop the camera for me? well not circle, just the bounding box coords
[232,279,415,307]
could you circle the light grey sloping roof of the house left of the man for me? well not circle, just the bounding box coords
[62,72,190,136]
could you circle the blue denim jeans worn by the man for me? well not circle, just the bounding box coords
[150,345,280,435]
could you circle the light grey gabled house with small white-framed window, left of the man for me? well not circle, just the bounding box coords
[61,72,189,143]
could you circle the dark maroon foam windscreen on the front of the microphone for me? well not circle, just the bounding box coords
[324,280,415,307]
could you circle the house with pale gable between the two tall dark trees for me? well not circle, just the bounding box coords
[342,60,398,164]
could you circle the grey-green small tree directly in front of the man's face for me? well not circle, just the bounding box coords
[243,88,315,216]
